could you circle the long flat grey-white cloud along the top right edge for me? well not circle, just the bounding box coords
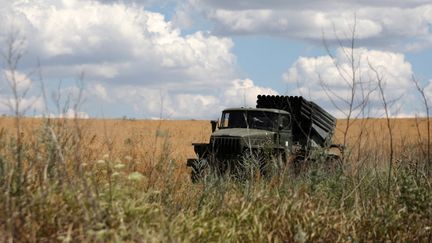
[189,0,432,49]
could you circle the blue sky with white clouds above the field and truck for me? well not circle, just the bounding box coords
[0,0,432,119]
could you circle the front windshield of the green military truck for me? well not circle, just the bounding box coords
[220,111,278,131]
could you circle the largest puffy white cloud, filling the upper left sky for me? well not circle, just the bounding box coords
[0,0,236,87]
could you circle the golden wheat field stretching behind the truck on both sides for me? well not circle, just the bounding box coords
[0,117,427,163]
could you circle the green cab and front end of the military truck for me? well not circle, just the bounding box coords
[187,107,292,181]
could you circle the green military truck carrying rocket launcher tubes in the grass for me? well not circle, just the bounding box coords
[187,95,336,182]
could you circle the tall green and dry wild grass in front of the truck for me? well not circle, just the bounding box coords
[0,119,432,242]
